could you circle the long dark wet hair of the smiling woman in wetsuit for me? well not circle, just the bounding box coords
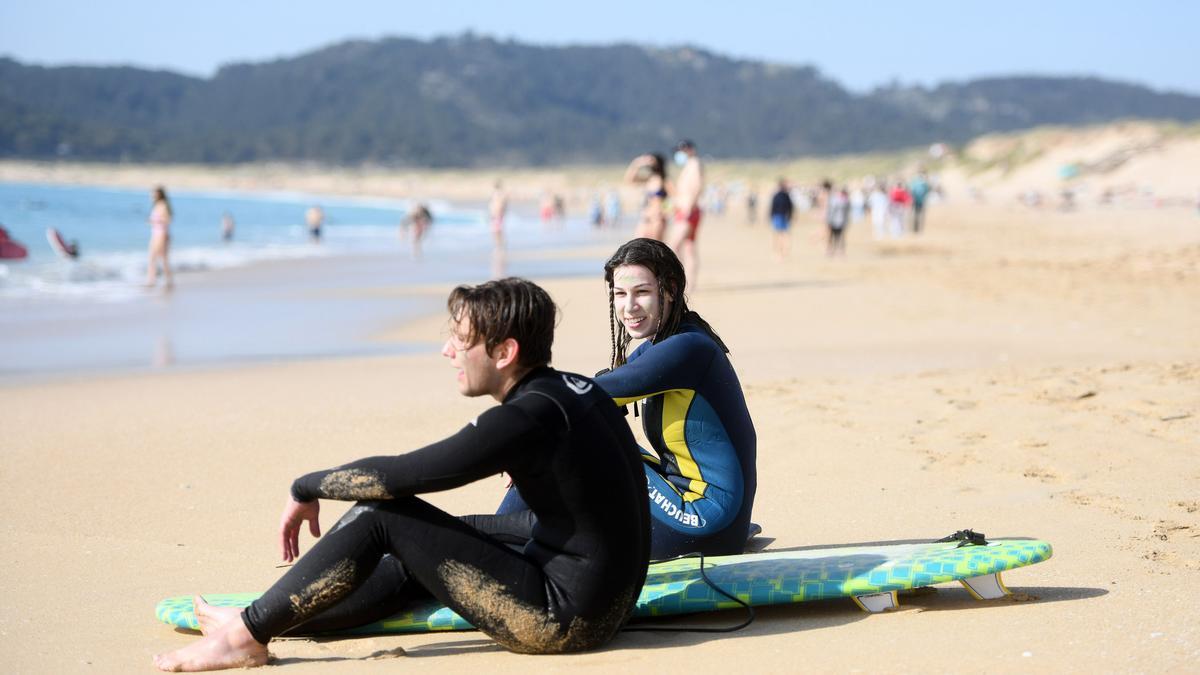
[604,238,730,368]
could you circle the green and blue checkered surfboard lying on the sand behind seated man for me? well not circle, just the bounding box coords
[155,538,1052,635]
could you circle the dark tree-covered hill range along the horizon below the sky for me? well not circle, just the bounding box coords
[0,34,1200,167]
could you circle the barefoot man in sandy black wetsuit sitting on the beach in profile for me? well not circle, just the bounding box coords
[155,279,649,671]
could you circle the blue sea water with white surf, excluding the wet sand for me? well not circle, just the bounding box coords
[0,184,552,300]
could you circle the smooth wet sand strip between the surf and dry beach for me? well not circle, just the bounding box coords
[0,233,624,379]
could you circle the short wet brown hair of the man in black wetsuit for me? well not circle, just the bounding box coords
[446,276,558,368]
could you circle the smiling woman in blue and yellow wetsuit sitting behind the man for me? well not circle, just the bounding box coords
[498,238,757,560]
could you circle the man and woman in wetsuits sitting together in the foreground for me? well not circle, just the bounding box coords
[155,235,757,670]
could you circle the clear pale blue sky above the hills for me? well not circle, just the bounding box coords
[0,0,1200,95]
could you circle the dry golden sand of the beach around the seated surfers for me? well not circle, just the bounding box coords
[0,158,1200,674]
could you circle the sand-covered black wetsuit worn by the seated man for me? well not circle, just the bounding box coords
[242,368,649,653]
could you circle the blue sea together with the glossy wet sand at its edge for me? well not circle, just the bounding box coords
[0,184,617,376]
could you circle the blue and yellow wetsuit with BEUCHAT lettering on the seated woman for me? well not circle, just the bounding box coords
[595,319,757,560]
